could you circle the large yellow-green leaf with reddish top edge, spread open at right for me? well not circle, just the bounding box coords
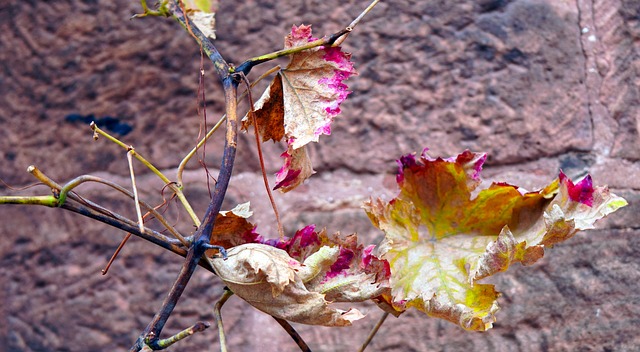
[365,150,626,331]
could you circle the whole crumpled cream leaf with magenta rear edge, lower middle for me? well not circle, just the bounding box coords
[211,224,390,326]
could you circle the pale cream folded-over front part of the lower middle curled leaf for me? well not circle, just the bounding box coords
[212,243,364,326]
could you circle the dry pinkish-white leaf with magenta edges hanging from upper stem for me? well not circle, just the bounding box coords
[244,25,356,192]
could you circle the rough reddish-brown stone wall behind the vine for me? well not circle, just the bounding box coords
[0,0,640,351]
